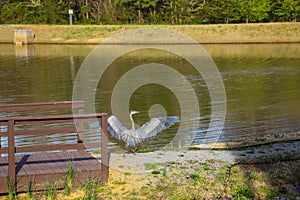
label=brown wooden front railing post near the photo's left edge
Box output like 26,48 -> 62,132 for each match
8,119 -> 17,191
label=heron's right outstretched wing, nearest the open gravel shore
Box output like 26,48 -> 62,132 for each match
137,116 -> 179,141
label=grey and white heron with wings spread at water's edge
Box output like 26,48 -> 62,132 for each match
90,110 -> 179,148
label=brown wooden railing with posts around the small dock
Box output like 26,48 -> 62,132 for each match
0,102 -> 109,191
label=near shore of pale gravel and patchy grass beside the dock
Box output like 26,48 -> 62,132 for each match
0,139 -> 300,200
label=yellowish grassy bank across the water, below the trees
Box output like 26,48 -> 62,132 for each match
0,23 -> 300,44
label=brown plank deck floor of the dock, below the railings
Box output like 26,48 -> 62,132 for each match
0,151 -> 102,194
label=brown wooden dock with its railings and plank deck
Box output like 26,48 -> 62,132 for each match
0,102 -> 109,194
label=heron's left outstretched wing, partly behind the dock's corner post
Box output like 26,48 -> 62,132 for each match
88,115 -> 127,140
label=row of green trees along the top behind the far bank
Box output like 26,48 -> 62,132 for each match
0,0 -> 300,24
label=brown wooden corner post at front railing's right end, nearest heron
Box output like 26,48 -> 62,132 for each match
101,115 -> 109,183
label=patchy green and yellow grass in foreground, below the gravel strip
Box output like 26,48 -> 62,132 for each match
0,160 -> 300,200
